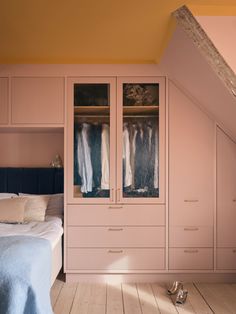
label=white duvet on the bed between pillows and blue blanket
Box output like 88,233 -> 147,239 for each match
0,216 -> 63,248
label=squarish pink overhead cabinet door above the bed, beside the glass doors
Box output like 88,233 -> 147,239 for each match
11,77 -> 64,125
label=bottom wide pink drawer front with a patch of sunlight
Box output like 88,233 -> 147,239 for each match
67,248 -> 165,271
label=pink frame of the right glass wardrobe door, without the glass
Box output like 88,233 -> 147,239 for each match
117,76 -> 166,204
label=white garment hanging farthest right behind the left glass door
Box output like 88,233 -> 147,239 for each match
101,124 -> 110,190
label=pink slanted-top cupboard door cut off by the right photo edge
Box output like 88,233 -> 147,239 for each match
217,128 -> 236,248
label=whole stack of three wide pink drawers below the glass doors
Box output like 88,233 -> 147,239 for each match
66,205 -> 165,273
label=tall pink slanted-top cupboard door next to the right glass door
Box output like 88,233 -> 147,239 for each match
169,83 -> 214,226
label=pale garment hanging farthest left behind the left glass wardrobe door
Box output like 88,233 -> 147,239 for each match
77,123 -> 93,193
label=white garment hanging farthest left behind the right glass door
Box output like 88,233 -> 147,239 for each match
122,123 -> 132,187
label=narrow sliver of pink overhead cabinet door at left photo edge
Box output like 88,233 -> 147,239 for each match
0,77 -> 9,124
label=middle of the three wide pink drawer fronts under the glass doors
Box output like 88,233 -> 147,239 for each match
67,226 -> 165,247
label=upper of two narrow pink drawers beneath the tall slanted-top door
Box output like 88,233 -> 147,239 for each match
170,226 -> 213,247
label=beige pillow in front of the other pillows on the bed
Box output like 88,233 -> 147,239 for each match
0,197 -> 27,223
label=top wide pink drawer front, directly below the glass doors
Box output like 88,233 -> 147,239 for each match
67,205 -> 165,226
